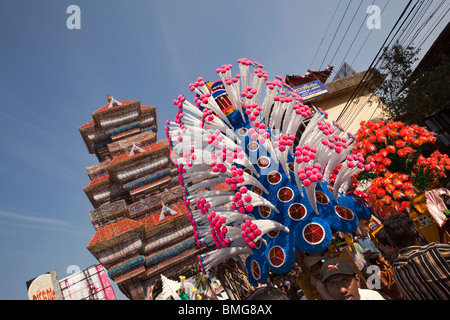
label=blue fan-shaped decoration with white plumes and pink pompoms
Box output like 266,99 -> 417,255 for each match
166,59 -> 374,285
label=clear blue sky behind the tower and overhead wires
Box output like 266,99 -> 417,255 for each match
0,0 -> 442,299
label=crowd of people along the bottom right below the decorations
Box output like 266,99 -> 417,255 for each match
248,214 -> 450,300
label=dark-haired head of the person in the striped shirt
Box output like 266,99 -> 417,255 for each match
383,214 -> 417,250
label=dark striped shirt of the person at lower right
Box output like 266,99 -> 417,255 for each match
393,242 -> 450,300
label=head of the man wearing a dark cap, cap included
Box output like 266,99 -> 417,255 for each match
320,258 -> 361,300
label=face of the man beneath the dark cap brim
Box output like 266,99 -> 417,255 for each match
325,274 -> 360,300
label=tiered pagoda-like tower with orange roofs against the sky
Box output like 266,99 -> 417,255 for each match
79,96 -> 203,300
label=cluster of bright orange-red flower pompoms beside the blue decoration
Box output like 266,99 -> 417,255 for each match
353,121 -> 450,217
